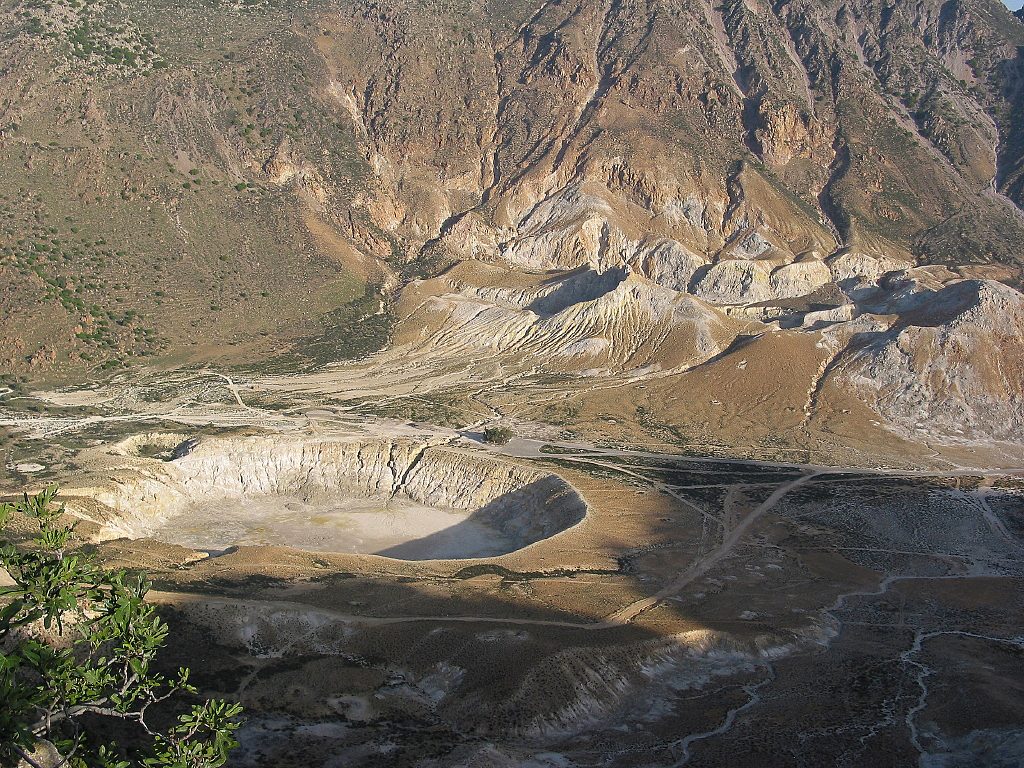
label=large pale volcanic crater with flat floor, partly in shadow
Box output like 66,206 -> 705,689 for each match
74,437 -> 587,560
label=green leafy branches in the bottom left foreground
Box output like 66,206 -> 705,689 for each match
0,486 -> 242,768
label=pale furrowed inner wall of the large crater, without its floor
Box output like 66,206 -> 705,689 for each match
69,436 -> 587,559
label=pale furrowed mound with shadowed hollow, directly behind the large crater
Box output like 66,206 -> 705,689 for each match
397,267 -> 741,374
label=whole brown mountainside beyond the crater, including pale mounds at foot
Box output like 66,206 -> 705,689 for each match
0,0 -> 1024,450
